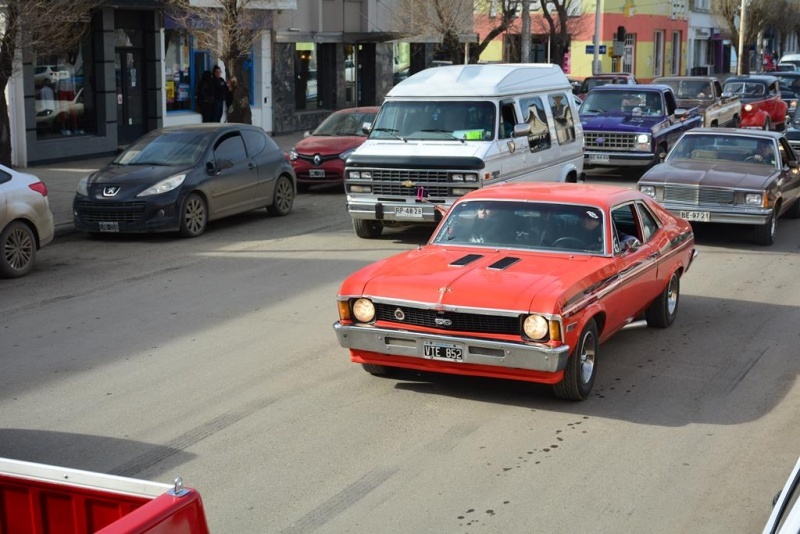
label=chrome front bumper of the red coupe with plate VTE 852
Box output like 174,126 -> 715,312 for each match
333,321 -> 569,373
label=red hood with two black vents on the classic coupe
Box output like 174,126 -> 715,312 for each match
340,246 -> 614,313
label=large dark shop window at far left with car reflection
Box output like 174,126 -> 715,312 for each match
33,44 -> 97,139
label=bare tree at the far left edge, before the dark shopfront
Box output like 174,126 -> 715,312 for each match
0,0 -> 100,166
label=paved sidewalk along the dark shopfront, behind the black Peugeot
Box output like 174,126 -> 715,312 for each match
25,132 -> 303,236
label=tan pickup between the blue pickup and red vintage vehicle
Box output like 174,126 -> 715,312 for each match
653,76 -> 742,128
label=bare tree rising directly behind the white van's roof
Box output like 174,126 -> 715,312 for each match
391,0 -> 519,64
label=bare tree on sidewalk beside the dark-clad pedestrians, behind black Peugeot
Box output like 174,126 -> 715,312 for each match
165,0 -> 272,124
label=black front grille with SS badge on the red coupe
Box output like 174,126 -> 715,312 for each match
375,304 -> 520,335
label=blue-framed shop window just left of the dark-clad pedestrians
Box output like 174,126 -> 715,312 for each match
164,30 -> 196,112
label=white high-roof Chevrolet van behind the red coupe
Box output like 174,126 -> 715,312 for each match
345,64 -> 583,238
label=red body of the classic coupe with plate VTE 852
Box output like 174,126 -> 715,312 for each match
334,184 -> 696,400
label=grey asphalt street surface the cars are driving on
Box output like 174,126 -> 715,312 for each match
0,177 -> 800,534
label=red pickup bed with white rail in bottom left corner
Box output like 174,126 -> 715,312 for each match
0,458 -> 209,534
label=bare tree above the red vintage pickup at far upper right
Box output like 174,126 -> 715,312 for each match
711,0 -> 781,74
